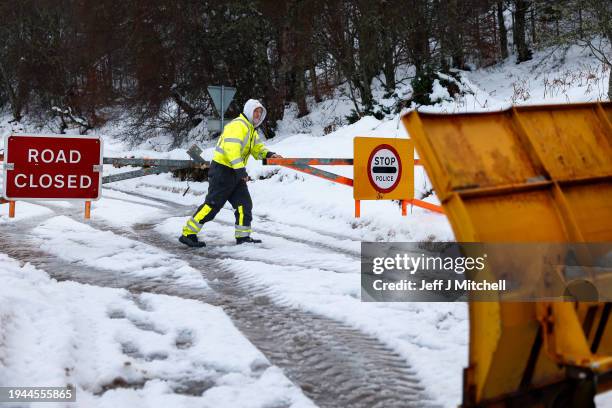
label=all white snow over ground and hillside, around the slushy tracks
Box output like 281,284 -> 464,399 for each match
0,43 -> 612,407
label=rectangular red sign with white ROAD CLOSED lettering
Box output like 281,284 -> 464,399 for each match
4,135 -> 102,200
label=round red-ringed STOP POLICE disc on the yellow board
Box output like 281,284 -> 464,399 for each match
368,144 -> 402,193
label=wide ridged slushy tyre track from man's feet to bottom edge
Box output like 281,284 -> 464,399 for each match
130,224 -> 437,408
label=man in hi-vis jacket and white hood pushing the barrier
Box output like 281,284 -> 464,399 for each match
179,99 -> 282,248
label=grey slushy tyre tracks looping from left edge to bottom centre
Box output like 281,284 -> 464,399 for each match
0,198 -> 436,408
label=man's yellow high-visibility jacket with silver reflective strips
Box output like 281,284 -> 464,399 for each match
213,114 -> 271,177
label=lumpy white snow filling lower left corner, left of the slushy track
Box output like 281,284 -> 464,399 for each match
0,255 -> 313,408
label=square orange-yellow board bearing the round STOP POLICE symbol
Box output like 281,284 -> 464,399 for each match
353,137 -> 414,200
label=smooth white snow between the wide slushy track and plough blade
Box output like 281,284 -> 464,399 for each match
224,260 -> 468,406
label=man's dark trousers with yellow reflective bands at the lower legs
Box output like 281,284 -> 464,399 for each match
183,161 -> 253,238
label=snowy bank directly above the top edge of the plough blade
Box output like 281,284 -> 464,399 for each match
419,46 -> 610,113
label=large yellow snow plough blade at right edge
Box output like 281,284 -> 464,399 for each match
402,103 -> 612,407
